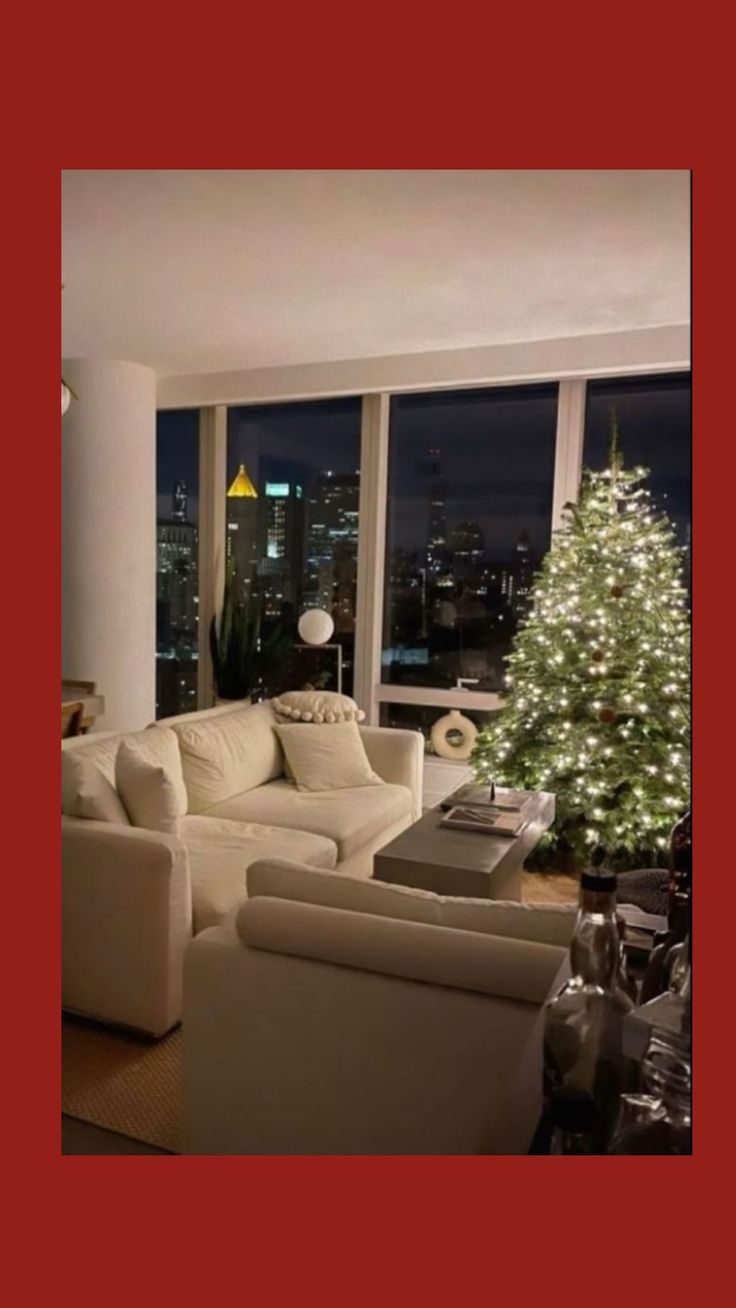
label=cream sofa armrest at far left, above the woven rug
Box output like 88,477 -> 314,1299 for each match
61,818 -> 191,1036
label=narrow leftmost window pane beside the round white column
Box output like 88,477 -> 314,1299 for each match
156,409 -> 199,718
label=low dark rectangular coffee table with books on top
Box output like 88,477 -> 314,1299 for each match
373,790 -> 554,900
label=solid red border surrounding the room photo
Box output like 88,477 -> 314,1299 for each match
3,15 -> 733,1304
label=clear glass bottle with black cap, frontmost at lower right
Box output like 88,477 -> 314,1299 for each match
544,867 -> 634,1154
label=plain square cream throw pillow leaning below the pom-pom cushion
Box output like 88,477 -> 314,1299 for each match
276,722 -> 383,790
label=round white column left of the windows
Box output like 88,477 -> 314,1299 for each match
61,358 -> 156,730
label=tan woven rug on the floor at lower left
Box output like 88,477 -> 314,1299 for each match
61,1018 -> 182,1154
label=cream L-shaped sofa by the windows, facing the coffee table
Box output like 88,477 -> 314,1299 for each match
61,702 -> 424,1036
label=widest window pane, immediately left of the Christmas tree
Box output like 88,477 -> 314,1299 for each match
382,385 -> 558,734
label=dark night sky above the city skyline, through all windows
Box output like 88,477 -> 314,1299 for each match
157,377 -> 690,559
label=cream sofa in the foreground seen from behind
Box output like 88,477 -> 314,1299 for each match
183,859 -> 575,1155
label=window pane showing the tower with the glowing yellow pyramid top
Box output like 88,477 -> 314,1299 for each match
226,398 -> 361,695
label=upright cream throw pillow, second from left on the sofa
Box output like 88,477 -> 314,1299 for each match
115,732 -> 187,836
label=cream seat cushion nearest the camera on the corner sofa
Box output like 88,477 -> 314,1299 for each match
179,814 -> 337,931
